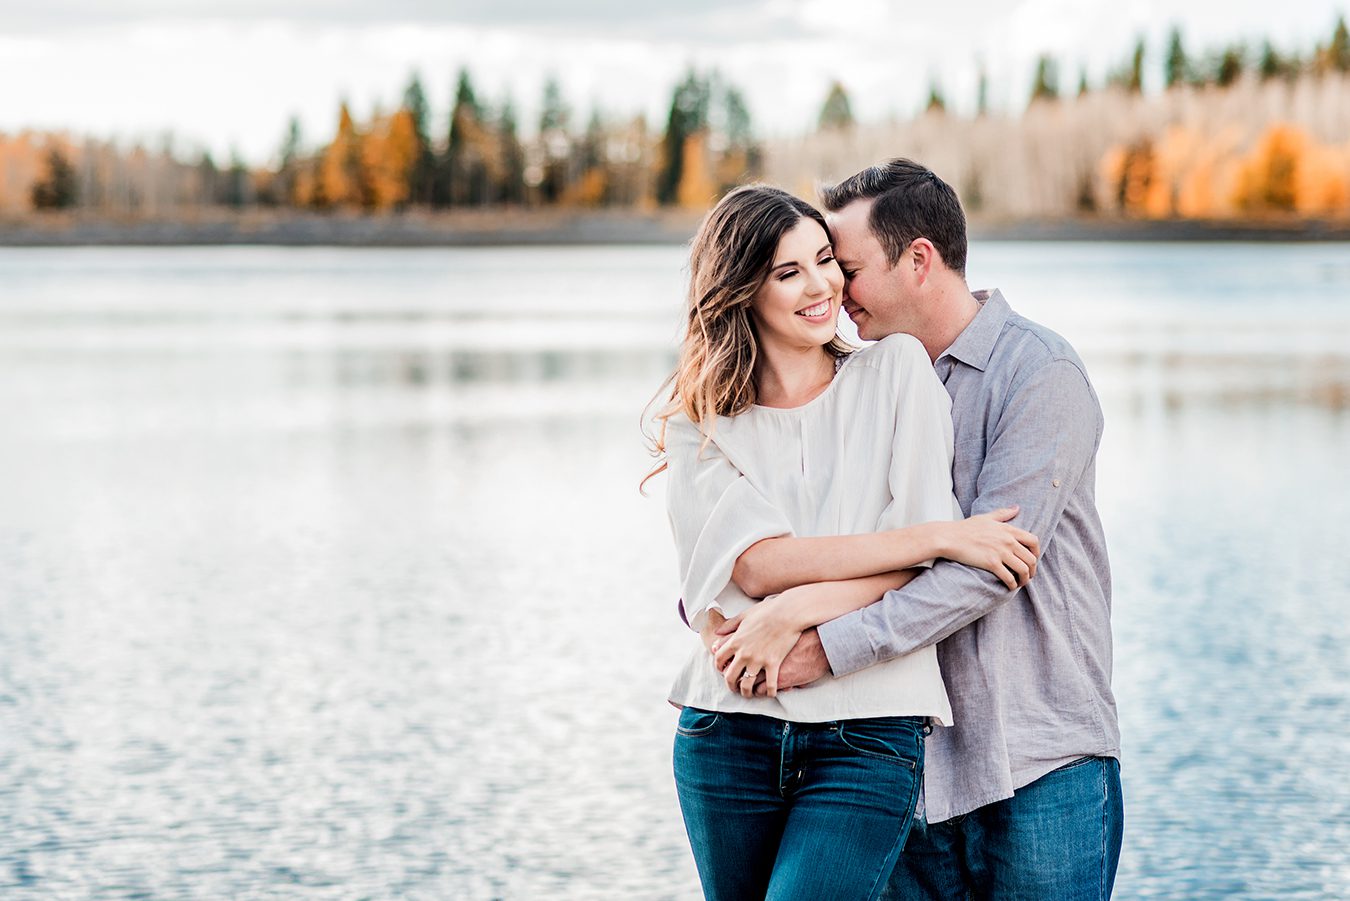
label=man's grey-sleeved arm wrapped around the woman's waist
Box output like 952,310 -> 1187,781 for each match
815,359 -> 1102,675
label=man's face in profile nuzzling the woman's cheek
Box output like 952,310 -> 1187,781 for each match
829,200 -> 918,340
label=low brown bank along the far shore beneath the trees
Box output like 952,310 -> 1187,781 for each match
0,209 -> 1350,247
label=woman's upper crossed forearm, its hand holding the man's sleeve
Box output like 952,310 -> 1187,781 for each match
732,507 -> 1040,599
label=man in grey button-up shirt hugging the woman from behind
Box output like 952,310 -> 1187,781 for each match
756,159 -> 1123,901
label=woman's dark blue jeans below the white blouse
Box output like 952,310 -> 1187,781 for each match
675,708 -> 925,901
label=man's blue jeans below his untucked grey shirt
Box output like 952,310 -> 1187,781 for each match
884,756 -> 1125,901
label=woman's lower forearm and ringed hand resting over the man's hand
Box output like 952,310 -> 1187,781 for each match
703,570 -> 917,697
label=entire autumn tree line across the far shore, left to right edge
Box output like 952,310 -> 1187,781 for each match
10,16 -> 1350,217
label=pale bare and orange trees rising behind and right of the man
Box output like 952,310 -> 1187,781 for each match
765,18 -> 1350,219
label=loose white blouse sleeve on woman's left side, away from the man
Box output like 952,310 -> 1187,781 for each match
666,415 -> 792,631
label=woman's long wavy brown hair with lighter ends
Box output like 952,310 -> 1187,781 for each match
643,185 -> 852,494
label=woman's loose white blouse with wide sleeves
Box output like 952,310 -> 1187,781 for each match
666,335 -> 961,725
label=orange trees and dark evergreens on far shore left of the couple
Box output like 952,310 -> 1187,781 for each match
10,69 -> 763,215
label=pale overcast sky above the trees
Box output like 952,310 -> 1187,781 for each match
0,0 -> 1350,162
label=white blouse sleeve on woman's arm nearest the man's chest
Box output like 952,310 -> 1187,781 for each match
876,335 -> 960,553
